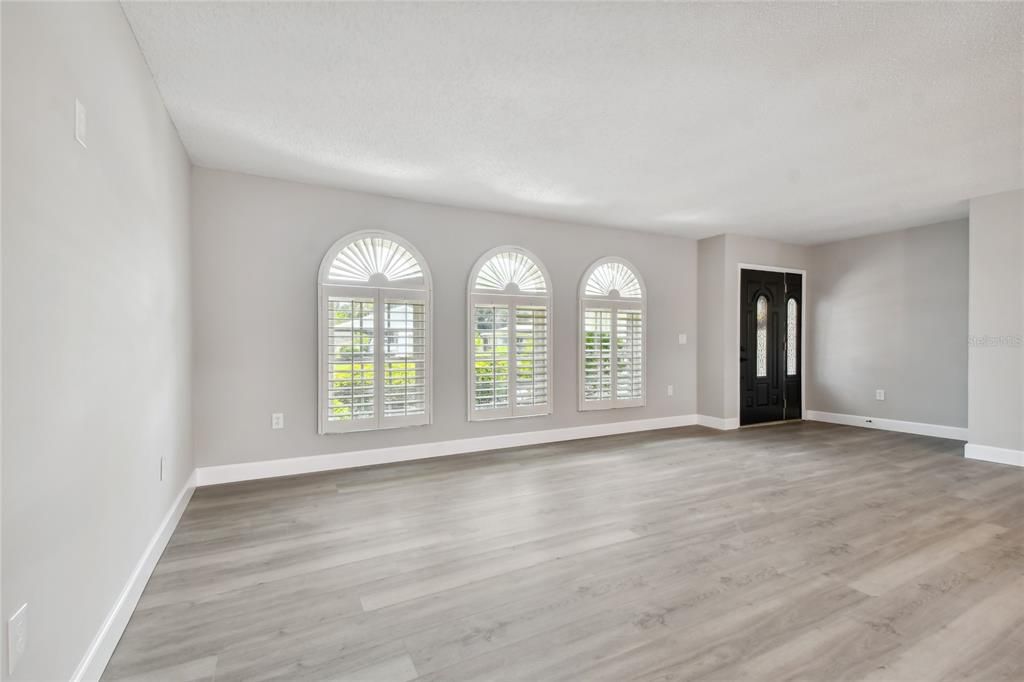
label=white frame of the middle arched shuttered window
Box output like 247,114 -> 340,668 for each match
466,246 -> 555,422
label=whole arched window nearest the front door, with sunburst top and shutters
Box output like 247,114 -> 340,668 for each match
580,258 -> 647,410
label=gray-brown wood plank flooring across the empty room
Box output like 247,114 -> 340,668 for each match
104,422 -> 1024,682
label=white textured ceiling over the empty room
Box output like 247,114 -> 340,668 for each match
124,2 -> 1024,243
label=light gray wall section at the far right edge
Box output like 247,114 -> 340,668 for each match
968,189 -> 1024,451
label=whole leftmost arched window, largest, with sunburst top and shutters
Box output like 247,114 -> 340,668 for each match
317,231 -> 431,433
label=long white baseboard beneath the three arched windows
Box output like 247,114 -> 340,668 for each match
196,415 -> 697,485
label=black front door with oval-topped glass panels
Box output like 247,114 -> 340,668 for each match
739,269 -> 804,425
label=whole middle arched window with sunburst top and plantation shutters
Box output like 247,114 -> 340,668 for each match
469,247 -> 551,421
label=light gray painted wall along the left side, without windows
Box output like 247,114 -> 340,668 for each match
2,3 -> 193,680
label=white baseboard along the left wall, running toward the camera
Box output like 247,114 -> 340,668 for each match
71,471 -> 196,682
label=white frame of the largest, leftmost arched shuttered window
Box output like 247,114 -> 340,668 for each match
316,230 -> 434,435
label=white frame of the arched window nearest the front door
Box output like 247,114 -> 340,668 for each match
577,256 -> 649,412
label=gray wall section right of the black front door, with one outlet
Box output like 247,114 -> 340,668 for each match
807,220 -> 968,427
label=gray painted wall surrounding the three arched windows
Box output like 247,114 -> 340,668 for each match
193,168 -> 697,466
